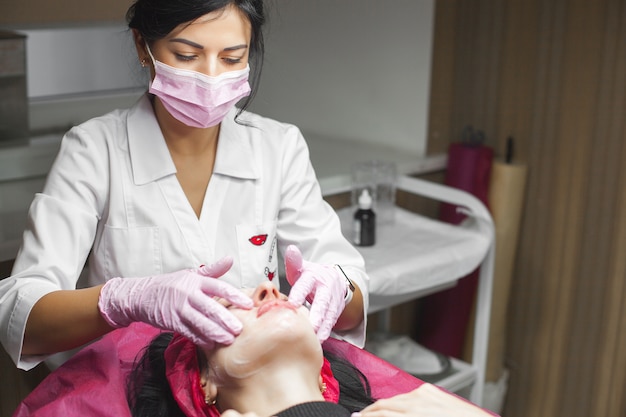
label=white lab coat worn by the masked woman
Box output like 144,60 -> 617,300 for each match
0,95 -> 368,369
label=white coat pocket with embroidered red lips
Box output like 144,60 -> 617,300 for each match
237,221 -> 279,288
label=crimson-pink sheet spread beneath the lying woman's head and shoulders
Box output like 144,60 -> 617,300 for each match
13,323 -> 423,417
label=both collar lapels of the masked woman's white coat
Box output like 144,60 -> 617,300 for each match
128,94 -> 259,185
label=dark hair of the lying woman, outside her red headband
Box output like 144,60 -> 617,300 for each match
127,333 -> 374,417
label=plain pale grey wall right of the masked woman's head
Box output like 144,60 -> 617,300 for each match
253,0 -> 434,156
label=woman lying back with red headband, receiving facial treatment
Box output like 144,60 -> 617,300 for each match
128,282 -> 490,417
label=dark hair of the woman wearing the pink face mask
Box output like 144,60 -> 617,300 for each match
126,0 -> 265,117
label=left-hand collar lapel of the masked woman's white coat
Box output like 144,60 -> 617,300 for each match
127,93 -> 176,185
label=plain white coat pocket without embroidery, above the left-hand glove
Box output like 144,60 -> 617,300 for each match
104,226 -> 162,278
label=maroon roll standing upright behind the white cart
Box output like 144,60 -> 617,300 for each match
417,143 -> 493,358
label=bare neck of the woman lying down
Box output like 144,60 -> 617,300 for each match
217,364 -> 324,417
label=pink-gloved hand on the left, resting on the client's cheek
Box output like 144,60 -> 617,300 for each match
98,257 -> 253,349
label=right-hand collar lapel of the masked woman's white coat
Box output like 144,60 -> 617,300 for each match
213,107 -> 259,179
